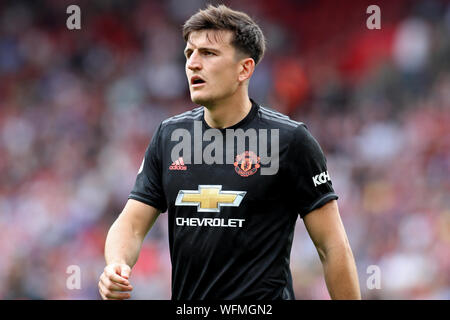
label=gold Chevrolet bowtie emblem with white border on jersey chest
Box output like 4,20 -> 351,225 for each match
175,185 -> 247,212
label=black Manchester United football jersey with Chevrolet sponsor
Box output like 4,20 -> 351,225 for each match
129,100 -> 338,300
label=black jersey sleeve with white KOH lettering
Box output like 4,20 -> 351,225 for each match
286,124 -> 338,218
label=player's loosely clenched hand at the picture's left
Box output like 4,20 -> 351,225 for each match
98,263 -> 133,300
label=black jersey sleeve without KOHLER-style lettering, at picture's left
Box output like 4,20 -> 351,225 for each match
128,125 -> 167,212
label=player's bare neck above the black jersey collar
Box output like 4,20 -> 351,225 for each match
205,94 -> 252,129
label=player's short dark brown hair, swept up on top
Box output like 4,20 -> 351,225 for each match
183,5 -> 266,64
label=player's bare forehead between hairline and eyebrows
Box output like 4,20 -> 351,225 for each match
186,29 -> 233,49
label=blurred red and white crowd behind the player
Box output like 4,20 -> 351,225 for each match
0,0 -> 450,299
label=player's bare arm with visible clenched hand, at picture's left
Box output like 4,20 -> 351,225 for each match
98,199 -> 161,300
